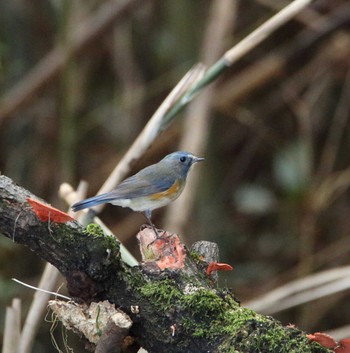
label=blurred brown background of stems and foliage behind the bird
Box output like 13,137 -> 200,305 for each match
0,0 -> 350,353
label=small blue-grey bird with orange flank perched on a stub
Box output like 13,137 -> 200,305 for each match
72,151 -> 204,229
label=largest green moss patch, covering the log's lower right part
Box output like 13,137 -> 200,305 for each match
140,278 -> 331,353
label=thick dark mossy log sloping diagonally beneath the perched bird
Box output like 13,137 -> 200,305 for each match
0,176 -> 329,353
